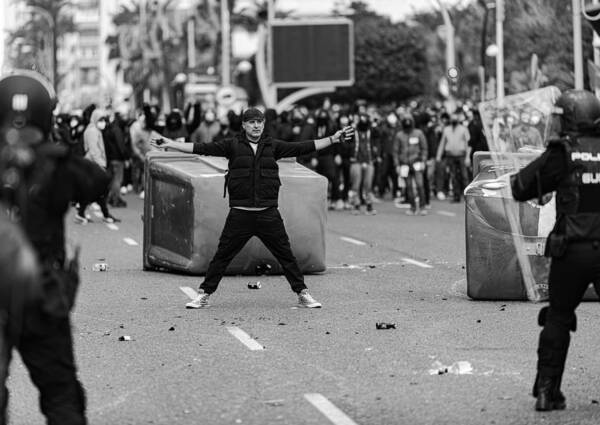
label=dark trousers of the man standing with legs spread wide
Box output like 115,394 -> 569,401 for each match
200,207 -> 306,294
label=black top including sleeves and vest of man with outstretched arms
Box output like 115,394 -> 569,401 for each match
194,132 -> 315,208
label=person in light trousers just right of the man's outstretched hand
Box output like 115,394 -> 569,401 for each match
348,114 -> 376,215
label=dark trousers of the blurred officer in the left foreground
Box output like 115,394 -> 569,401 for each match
0,313 -> 87,425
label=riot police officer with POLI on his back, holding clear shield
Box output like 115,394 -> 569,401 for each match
510,90 -> 600,411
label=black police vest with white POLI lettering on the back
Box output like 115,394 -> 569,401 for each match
555,136 -> 600,241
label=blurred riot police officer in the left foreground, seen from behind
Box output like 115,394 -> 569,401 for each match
0,71 -> 108,425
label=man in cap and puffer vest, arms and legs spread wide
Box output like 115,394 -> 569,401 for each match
154,108 -> 352,308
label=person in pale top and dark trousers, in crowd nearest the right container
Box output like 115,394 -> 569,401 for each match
436,114 -> 471,202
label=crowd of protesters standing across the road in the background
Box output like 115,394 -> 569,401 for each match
54,97 -> 488,220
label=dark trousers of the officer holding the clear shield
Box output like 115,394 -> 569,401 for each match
538,242 -> 600,376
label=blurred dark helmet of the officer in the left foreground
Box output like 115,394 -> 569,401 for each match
0,70 -> 56,144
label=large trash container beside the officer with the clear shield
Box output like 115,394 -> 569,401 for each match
465,152 -> 597,300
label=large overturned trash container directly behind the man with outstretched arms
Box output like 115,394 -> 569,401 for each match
143,152 -> 327,275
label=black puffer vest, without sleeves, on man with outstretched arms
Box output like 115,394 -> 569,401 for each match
226,134 -> 281,208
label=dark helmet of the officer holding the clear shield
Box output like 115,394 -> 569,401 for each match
555,90 -> 600,133
